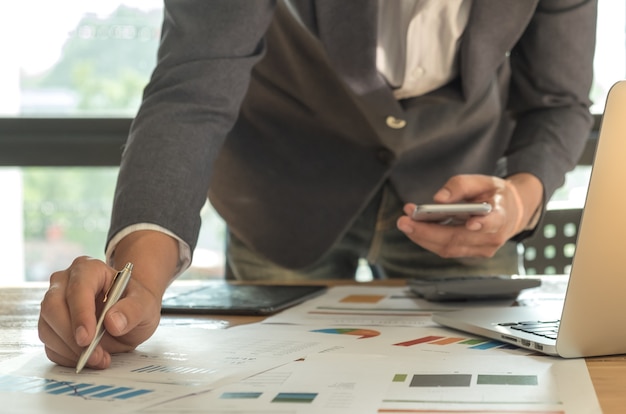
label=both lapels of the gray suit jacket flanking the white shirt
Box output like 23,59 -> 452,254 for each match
315,0 -> 538,109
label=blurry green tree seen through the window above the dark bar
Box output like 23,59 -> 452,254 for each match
31,5 -> 162,116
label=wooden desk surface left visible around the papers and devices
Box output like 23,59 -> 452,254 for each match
0,281 -> 626,414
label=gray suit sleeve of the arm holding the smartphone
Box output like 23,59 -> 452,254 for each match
507,0 -> 597,201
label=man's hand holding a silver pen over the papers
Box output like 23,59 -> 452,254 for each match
38,231 -> 178,369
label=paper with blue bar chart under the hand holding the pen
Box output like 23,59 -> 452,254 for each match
0,324 -> 354,414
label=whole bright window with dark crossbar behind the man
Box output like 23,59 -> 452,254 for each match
0,0 -> 626,283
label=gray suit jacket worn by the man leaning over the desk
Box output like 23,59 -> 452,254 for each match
109,0 -> 596,267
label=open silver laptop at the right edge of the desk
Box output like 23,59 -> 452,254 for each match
433,81 -> 626,358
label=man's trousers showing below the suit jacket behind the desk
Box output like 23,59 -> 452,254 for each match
226,183 -> 522,281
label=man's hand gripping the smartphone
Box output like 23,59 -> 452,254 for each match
397,173 -> 543,258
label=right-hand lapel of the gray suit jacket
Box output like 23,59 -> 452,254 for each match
460,0 -> 538,99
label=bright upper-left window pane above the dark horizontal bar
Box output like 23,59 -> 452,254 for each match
0,0 -> 162,117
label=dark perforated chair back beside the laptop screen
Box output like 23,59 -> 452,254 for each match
523,208 -> 582,275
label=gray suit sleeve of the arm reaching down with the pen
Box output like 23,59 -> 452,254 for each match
108,0 -> 274,251
